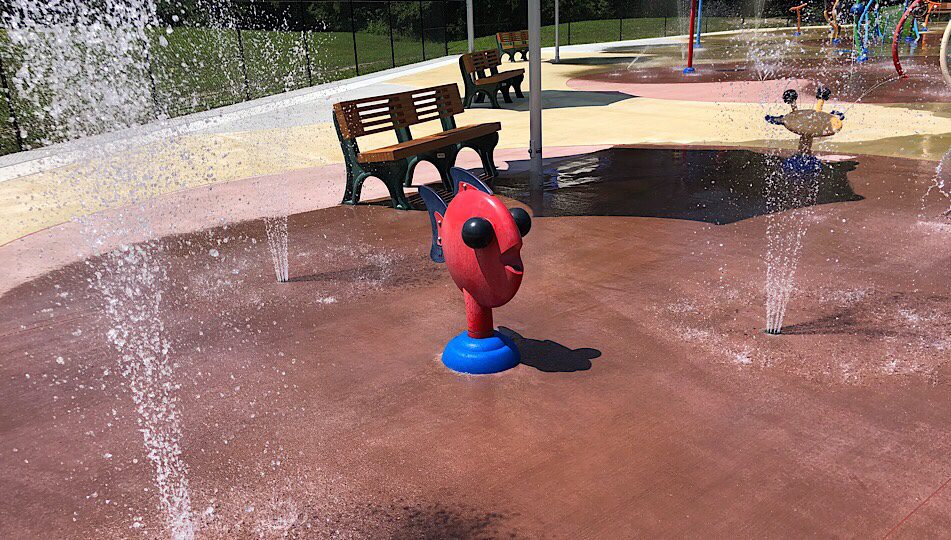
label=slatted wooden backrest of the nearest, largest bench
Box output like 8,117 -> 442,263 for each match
334,84 -> 463,139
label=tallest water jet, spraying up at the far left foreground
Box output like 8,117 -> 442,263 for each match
4,0 -> 195,540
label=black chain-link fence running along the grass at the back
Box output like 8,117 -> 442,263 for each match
0,0 -> 821,155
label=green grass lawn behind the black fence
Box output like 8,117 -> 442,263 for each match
0,17 -> 768,155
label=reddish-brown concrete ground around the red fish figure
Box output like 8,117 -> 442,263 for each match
0,149 -> 951,538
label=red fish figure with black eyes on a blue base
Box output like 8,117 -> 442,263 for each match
419,167 -> 532,374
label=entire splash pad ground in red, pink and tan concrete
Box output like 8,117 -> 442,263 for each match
0,11 -> 951,539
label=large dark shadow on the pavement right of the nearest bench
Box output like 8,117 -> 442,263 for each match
493,147 -> 862,225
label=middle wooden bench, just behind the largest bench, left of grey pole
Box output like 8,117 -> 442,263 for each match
459,49 -> 525,109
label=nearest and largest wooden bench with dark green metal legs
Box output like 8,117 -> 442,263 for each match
334,84 -> 502,210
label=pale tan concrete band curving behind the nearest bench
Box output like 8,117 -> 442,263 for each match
0,26 -> 951,245
